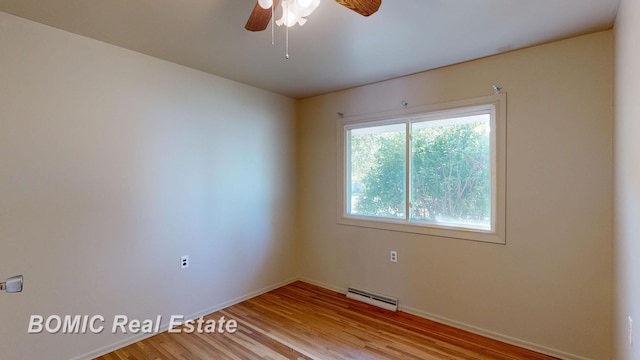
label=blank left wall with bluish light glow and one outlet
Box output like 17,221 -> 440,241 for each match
0,13 -> 296,360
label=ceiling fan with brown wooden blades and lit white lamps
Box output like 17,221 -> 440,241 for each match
244,0 -> 382,31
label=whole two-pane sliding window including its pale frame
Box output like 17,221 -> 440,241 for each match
338,94 -> 506,243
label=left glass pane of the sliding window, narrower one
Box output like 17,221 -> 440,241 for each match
347,123 -> 406,219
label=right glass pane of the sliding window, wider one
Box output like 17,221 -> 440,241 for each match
411,114 -> 491,230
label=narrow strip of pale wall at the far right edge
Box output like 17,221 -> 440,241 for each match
612,0 -> 640,360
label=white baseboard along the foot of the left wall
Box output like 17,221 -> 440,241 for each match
71,278 -> 298,360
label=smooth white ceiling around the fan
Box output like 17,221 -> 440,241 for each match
0,0 -> 620,98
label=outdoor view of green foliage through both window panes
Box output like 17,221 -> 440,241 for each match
349,114 -> 491,229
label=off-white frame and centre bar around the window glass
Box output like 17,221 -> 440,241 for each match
337,93 -> 506,244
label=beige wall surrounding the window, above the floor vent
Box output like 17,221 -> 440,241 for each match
298,31 -> 612,359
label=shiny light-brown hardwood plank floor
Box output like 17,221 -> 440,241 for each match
98,282 -> 555,360
